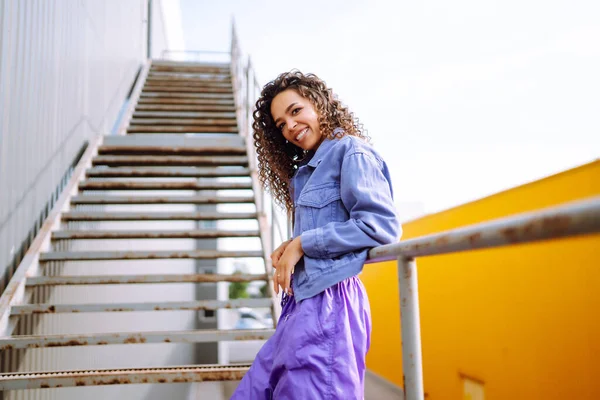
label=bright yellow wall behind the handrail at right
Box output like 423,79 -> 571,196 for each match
361,161 -> 600,400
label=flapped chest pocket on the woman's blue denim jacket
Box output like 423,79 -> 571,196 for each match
297,183 -> 344,231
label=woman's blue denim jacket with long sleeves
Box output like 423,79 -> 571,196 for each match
291,133 -> 401,302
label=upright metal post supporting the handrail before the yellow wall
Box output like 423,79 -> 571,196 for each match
398,256 -> 424,400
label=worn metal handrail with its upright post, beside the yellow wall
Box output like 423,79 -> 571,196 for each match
367,196 -> 600,400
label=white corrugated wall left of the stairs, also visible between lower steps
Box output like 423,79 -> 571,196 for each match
0,0 -> 209,400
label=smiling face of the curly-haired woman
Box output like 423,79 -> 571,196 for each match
271,89 -> 324,150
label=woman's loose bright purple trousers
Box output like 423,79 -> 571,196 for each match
231,276 -> 371,400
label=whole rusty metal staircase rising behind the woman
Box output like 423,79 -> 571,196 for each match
0,57 -> 277,391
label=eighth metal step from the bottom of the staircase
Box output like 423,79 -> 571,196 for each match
71,195 -> 254,204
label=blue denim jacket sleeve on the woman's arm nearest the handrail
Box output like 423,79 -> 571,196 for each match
301,152 -> 402,258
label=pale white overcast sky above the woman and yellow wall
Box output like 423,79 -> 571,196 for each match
165,0 -> 600,219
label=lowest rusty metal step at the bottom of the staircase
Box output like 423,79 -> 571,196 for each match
0,365 -> 250,390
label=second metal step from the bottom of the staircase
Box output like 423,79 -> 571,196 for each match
0,329 -> 275,350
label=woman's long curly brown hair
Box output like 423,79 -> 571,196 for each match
252,70 -> 370,213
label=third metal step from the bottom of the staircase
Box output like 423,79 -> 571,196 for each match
11,298 -> 273,315
